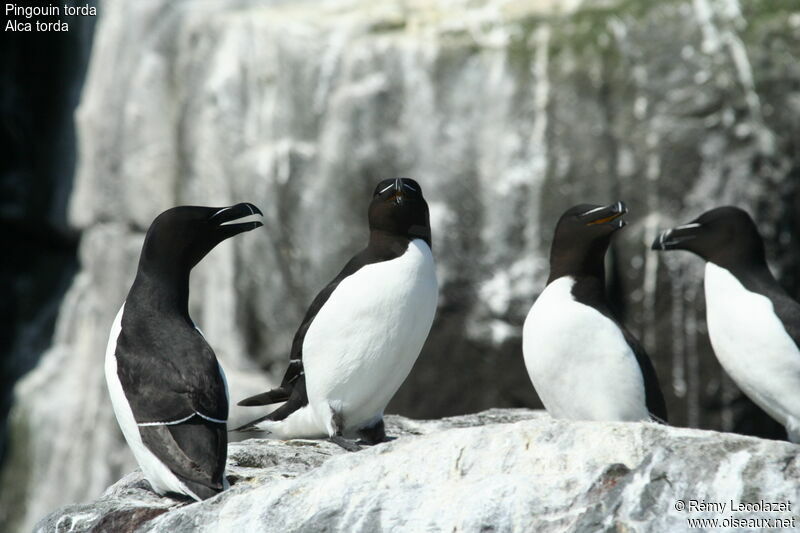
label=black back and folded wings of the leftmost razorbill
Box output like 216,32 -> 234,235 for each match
115,312 -> 228,498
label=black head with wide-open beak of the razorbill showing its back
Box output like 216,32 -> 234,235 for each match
139,203 -> 262,274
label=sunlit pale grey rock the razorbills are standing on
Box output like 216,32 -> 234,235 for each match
35,409 -> 800,533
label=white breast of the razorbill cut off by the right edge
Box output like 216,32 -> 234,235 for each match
705,262 -> 800,440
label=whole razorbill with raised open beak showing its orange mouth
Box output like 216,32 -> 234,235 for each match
522,202 -> 667,422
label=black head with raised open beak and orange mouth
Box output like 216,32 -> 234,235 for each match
549,202 -> 628,281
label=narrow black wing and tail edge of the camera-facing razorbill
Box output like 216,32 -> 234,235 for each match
239,241 -> 408,410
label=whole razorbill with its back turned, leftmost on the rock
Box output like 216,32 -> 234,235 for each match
105,203 -> 261,500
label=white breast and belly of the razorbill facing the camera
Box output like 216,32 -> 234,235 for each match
303,239 -> 438,428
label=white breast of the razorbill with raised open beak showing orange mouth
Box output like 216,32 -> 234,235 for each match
522,276 -> 649,420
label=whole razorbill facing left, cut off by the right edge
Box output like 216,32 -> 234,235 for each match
653,206 -> 800,442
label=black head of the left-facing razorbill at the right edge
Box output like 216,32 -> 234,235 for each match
653,206 -> 766,267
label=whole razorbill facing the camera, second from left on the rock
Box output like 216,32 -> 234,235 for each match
238,178 -> 438,450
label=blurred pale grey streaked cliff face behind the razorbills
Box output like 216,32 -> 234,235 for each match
0,0 -> 800,531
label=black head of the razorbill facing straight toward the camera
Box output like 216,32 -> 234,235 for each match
369,178 -> 431,246
